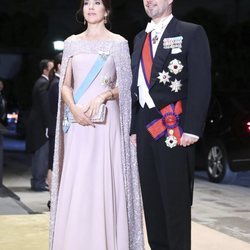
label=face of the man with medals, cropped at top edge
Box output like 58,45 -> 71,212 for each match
143,0 -> 173,20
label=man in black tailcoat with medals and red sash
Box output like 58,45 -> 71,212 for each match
131,0 -> 210,250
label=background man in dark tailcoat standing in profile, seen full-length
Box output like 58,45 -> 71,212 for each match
26,59 -> 53,191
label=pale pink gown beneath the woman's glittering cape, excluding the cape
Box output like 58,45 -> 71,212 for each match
53,53 -> 129,250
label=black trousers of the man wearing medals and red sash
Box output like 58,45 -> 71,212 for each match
137,107 -> 193,250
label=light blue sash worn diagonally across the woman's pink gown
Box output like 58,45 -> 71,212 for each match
62,54 -> 108,133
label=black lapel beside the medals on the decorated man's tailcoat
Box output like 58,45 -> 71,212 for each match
150,17 -> 178,88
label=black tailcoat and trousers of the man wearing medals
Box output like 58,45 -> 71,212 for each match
131,18 -> 211,250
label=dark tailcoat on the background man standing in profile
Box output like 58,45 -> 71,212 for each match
26,76 -> 49,153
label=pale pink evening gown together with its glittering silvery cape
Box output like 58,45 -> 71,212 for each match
51,39 -> 143,250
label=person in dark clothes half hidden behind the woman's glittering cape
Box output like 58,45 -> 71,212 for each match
47,53 -> 62,208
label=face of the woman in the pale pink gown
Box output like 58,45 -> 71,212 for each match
83,0 -> 107,24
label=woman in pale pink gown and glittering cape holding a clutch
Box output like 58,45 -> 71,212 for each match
51,0 -> 144,250
